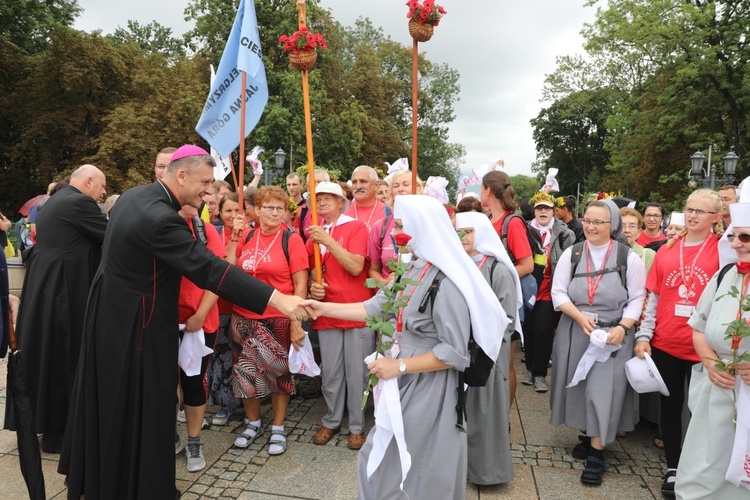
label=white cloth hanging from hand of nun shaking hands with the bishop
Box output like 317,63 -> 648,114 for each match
365,353 -> 411,491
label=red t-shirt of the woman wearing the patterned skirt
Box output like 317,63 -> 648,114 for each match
233,226 -> 307,319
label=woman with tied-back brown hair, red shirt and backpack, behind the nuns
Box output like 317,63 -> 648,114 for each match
481,170 -> 534,404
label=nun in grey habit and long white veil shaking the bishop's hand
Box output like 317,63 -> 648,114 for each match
303,195 -> 510,500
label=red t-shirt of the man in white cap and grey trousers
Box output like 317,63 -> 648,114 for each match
307,219 -> 375,330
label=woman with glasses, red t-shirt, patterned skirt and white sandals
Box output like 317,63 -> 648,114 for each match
231,186 -> 308,455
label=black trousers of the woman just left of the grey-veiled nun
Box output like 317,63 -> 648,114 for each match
523,300 -> 560,377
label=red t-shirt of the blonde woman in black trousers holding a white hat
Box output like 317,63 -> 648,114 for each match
646,233 -> 719,362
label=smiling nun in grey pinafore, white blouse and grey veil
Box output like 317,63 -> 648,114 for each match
550,200 -> 646,485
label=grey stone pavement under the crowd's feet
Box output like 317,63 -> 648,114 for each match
0,350 -> 665,500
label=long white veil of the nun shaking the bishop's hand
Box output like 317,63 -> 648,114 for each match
394,195 -> 510,359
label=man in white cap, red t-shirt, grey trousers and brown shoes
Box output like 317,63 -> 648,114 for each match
307,182 -> 375,450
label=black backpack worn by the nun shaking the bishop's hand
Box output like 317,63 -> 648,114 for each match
419,260 -> 497,429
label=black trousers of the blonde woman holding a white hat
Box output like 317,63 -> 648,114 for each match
651,347 -> 695,469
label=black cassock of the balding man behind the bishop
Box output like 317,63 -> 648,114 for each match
16,186 -> 107,446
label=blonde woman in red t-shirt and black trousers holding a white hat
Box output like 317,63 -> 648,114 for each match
635,189 -> 724,496
